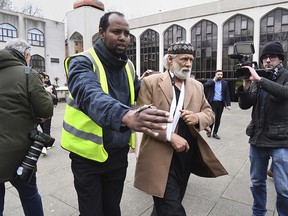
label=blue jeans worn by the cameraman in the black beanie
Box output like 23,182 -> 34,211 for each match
250,145 -> 288,216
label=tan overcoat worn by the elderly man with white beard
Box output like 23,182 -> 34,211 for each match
134,71 -> 227,197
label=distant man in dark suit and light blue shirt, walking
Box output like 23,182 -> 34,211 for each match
203,70 -> 231,139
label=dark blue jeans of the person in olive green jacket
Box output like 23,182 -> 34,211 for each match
0,174 -> 44,216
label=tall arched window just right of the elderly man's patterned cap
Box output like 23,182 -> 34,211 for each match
191,20 -> 218,79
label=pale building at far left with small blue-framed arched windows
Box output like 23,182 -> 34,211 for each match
0,9 -> 66,85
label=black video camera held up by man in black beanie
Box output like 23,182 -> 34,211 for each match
228,42 -> 273,79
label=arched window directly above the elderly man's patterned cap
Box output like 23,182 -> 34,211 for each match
164,25 -> 186,54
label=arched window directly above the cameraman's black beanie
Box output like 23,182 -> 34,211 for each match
259,8 -> 288,67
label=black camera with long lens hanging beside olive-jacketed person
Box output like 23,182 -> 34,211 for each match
17,129 -> 55,182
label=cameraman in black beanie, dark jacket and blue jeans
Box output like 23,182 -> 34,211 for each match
237,42 -> 288,216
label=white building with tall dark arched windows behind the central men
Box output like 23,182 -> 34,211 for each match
67,0 -> 288,97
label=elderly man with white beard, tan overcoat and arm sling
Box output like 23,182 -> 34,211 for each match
134,42 -> 226,216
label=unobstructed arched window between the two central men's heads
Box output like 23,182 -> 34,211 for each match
140,29 -> 159,75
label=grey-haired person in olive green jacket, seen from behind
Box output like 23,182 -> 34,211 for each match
0,38 -> 53,216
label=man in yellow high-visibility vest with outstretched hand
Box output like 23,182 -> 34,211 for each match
61,12 -> 171,216
